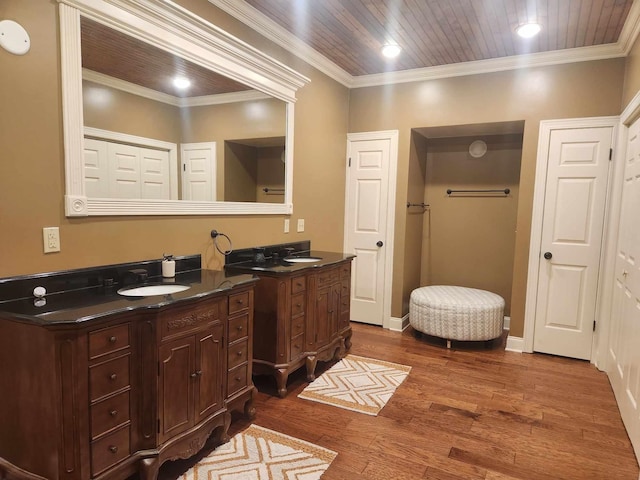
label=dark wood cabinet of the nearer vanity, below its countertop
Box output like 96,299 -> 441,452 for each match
0,283 -> 255,480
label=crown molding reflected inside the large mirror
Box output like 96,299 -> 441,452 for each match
82,68 -> 273,107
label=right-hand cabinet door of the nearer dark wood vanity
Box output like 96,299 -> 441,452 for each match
195,324 -> 226,423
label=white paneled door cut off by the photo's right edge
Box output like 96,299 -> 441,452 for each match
607,114 -> 640,455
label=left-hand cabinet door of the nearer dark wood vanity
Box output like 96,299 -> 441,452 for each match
158,336 -> 195,443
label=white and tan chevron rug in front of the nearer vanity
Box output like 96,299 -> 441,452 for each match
178,425 -> 337,480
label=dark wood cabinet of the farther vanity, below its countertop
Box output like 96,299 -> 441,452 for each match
253,259 -> 351,397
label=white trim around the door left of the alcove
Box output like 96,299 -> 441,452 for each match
343,130 -> 402,329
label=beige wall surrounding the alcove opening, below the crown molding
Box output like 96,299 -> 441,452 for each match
349,59 -> 624,336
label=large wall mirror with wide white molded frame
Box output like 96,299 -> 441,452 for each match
59,0 -> 308,216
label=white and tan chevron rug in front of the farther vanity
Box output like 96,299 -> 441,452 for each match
298,355 -> 411,415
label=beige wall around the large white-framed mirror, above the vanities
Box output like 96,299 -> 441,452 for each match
0,0 -> 349,277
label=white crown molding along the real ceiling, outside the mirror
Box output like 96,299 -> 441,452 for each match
209,0 -> 640,88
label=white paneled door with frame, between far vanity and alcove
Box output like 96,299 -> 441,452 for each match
345,132 -> 397,325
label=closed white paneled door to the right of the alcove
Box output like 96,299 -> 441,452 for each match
533,126 -> 614,360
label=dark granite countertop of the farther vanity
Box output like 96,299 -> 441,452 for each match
224,250 -> 355,275
